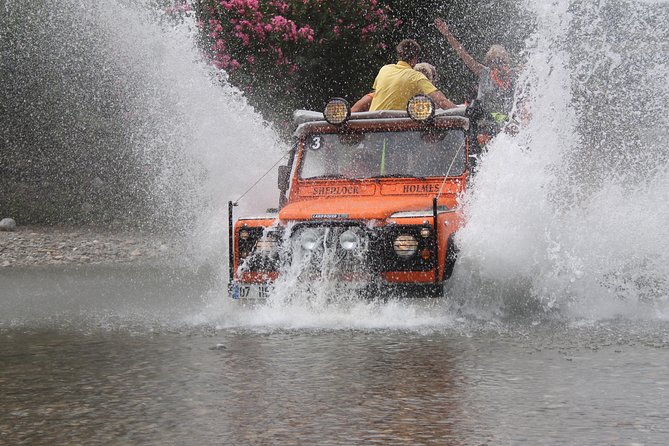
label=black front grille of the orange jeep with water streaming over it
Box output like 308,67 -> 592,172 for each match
235,221 -> 437,283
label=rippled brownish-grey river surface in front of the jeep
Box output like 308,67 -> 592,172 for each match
0,269 -> 669,445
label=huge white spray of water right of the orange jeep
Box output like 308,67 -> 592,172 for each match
451,1 -> 669,318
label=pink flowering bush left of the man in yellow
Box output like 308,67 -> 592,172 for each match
197,0 -> 398,127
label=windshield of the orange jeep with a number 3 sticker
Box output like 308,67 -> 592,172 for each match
300,129 -> 466,180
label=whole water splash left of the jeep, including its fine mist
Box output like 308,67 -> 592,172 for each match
0,0 -> 284,261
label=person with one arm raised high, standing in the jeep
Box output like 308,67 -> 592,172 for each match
434,18 -> 517,141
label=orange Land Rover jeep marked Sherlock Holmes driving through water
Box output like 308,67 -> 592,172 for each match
229,96 -> 469,298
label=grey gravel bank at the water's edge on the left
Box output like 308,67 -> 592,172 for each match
0,227 -> 183,269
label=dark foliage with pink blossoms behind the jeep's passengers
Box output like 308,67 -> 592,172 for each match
198,0 -> 530,123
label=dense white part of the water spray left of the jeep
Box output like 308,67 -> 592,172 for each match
82,2 -> 285,262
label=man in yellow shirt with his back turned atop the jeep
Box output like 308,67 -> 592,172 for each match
369,39 -> 455,110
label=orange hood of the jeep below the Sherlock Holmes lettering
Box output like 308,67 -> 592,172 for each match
279,196 -> 456,221
